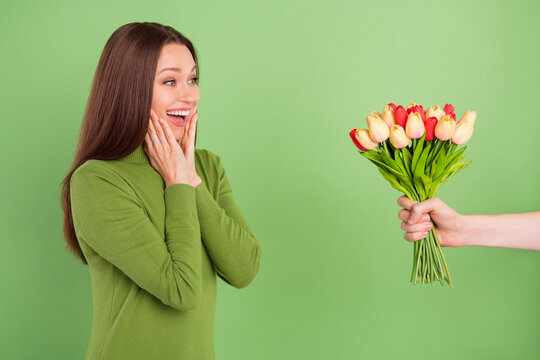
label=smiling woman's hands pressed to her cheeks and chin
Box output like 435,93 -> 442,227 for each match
144,110 -> 201,187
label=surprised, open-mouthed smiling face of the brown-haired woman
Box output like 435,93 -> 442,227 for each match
152,44 -> 199,142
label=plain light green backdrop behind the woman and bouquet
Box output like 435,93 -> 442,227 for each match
0,0 -> 540,360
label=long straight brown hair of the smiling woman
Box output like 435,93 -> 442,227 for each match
61,22 -> 199,264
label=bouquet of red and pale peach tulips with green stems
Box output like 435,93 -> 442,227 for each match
350,103 -> 476,286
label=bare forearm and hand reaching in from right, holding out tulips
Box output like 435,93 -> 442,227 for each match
398,196 -> 540,250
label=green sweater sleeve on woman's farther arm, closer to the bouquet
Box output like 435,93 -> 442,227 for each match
195,154 -> 261,288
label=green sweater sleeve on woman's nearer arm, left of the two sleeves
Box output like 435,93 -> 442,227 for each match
70,165 -> 202,310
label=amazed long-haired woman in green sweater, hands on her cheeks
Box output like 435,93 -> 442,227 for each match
62,23 -> 261,360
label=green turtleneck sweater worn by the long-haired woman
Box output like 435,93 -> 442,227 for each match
71,144 -> 261,360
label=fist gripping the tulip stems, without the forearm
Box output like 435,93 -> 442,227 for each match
398,196 -> 464,246
